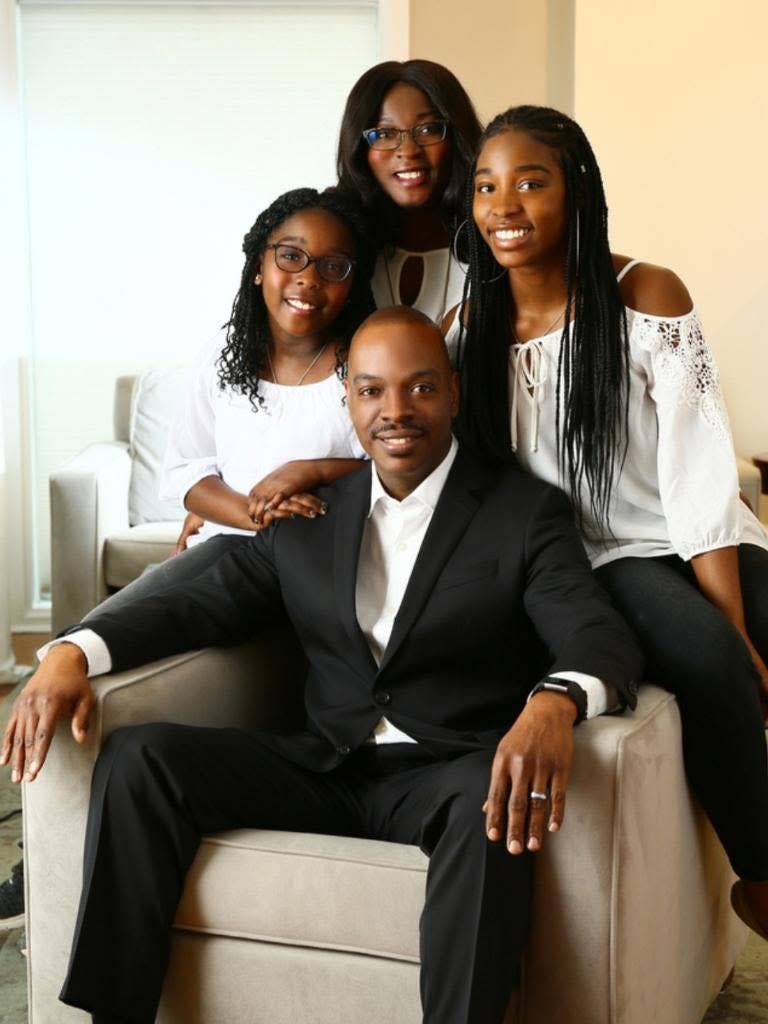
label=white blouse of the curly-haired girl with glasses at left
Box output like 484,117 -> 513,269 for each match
161,337 -> 366,543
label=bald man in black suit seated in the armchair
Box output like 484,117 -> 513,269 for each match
2,309 -> 641,1024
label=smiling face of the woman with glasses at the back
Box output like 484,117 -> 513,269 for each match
368,82 -> 451,209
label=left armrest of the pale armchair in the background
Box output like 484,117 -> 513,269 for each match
49,441 -> 131,634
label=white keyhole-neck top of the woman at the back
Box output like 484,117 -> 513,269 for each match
371,249 -> 467,324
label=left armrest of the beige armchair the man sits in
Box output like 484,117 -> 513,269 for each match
23,630 -> 305,1024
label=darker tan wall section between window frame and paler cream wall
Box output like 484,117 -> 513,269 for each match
410,0 -> 573,121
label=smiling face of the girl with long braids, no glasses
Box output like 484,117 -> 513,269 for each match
472,131 -> 567,269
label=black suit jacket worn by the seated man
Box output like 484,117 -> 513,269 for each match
83,451 -> 642,770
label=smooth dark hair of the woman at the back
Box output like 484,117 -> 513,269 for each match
336,59 -> 482,246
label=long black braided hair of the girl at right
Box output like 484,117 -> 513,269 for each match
460,105 -> 629,528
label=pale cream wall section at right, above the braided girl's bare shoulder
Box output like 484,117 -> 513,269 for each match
574,0 -> 768,455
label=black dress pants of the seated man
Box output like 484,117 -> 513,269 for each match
60,724 -> 532,1024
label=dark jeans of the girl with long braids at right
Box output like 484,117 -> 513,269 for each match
596,544 -> 768,882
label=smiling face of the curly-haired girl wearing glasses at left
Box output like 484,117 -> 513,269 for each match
255,209 -> 355,345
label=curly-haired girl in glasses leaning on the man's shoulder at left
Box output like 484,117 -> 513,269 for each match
83,188 -> 376,609
